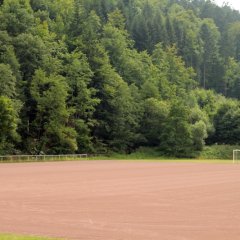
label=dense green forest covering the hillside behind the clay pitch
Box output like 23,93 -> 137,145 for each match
0,0 -> 240,157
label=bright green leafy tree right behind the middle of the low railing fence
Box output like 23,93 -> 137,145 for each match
30,70 -> 77,153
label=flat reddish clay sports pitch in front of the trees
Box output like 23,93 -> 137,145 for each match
0,161 -> 240,240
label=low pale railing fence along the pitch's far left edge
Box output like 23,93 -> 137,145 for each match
0,154 -> 90,162
